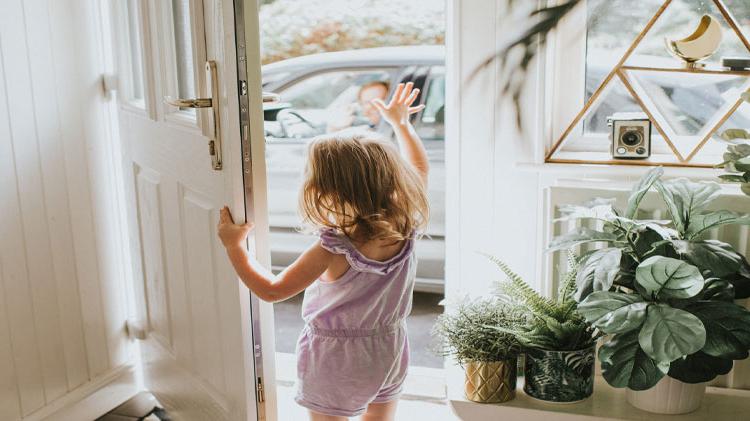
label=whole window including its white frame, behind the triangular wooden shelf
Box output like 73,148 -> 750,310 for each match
552,0 -> 750,161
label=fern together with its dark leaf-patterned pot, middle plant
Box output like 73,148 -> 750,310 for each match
490,257 -> 596,403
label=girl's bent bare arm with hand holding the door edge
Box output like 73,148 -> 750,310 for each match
218,207 -> 333,302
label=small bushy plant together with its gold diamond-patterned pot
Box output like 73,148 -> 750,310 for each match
433,298 -> 523,403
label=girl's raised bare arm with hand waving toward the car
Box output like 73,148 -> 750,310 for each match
373,82 -> 430,185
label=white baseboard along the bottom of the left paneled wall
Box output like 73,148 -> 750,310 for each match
23,365 -> 138,421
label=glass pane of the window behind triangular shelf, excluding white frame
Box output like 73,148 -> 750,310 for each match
585,0 -> 750,136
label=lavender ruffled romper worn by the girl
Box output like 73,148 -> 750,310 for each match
295,230 -> 416,417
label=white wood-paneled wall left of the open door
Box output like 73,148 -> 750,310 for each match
0,0 -> 130,420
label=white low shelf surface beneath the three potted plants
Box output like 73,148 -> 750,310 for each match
447,367 -> 750,421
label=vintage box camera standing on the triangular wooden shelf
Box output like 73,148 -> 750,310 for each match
607,113 -> 651,159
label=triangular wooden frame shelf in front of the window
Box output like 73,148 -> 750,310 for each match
545,0 -> 750,167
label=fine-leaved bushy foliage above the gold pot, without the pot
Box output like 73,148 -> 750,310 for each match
433,298 -> 525,363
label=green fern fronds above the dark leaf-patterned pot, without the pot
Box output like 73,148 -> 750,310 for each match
487,255 -> 596,351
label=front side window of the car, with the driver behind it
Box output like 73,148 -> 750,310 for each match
266,69 -> 400,138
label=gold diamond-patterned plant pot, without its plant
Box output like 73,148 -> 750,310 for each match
464,358 -> 517,403
